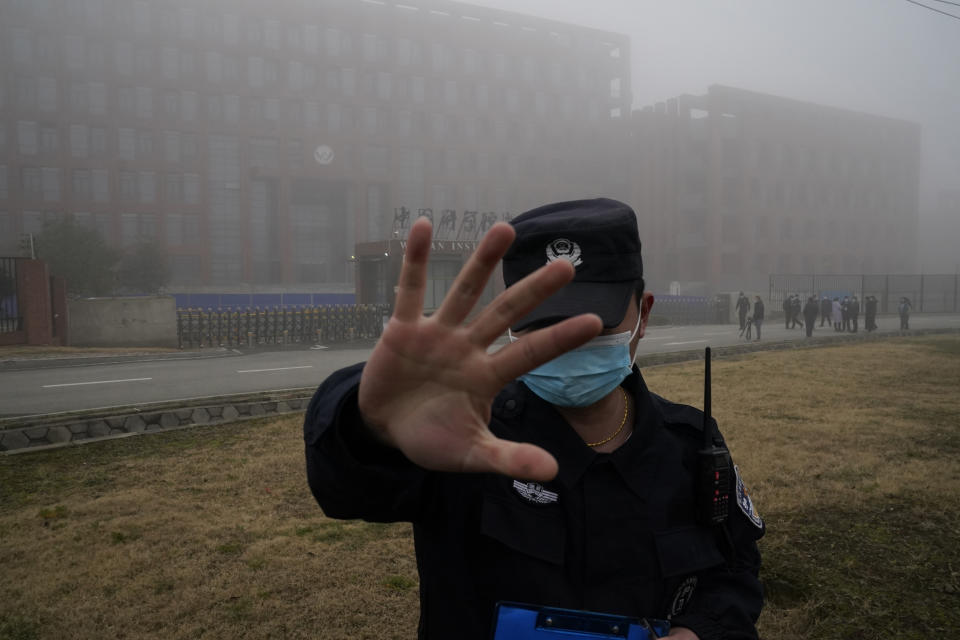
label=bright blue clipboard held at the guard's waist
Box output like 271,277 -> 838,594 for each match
491,602 -> 670,640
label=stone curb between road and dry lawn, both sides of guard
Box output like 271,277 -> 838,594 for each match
0,328 -> 960,455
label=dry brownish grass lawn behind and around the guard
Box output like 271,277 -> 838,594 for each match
0,335 -> 960,640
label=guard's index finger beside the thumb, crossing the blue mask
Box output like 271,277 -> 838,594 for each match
490,314 -> 603,387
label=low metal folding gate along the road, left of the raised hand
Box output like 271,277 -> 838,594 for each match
177,304 -> 390,349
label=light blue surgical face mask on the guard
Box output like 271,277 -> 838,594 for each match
510,317 -> 640,407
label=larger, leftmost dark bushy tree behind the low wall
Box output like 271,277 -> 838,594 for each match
36,218 -> 120,296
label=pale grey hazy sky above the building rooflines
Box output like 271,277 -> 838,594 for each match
470,0 -> 960,205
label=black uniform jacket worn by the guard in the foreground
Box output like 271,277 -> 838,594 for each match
304,365 -> 764,640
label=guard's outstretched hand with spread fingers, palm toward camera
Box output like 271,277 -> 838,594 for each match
358,218 -> 603,481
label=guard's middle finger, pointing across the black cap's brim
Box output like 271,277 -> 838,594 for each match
470,260 -> 575,345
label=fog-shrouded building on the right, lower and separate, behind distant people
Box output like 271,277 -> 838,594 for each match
631,86 -> 920,293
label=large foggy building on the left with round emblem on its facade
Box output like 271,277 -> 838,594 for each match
0,0 -> 631,286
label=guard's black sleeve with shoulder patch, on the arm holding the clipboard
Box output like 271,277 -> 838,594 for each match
671,460 -> 766,640
